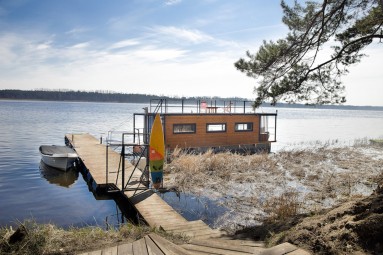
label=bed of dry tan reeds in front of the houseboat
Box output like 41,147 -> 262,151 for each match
165,139 -> 383,228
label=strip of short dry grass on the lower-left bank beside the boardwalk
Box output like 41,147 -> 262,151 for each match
0,220 -> 187,254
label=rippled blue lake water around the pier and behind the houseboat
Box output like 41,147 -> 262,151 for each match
0,100 -> 383,227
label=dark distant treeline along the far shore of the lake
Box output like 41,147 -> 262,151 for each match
0,89 -> 383,111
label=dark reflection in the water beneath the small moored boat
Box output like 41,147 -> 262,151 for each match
40,160 -> 79,188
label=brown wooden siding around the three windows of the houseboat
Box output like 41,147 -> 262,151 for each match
164,114 -> 260,149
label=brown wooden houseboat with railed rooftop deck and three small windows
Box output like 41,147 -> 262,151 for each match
134,100 -> 277,153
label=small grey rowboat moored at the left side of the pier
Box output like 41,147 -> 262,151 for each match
39,145 -> 78,171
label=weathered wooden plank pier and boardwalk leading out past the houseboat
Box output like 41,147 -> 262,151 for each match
65,134 -> 309,255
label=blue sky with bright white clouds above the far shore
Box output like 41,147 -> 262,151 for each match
0,0 -> 383,106
